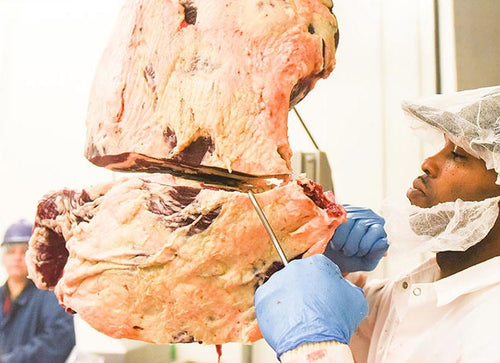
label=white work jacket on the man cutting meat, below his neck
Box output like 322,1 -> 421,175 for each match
350,257 -> 500,363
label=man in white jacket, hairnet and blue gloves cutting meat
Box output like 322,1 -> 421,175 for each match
255,87 -> 500,363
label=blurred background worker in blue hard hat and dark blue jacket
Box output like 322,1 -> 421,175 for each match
0,220 -> 75,363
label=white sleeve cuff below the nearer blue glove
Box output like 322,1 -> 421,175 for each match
280,341 -> 354,363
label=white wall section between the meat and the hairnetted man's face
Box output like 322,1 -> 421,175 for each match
289,0 -> 438,282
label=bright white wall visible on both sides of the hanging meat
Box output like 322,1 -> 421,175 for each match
0,0 -> 434,363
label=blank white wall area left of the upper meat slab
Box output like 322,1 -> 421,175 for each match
0,0 -> 122,247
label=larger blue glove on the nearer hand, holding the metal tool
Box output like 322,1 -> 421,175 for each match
254,255 -> 368,358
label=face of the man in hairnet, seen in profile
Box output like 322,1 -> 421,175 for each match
406,139 -> 500,208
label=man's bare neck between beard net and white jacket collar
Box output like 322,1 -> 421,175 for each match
436,218 -> 500,278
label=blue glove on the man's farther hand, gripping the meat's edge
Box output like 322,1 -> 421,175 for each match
324,205 -> 389,272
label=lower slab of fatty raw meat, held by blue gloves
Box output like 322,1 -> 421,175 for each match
26,175 -> 346,344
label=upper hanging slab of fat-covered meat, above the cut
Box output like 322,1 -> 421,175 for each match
85,0 -> 338,179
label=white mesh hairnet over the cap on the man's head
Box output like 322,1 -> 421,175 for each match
402,86 -> 500,184
